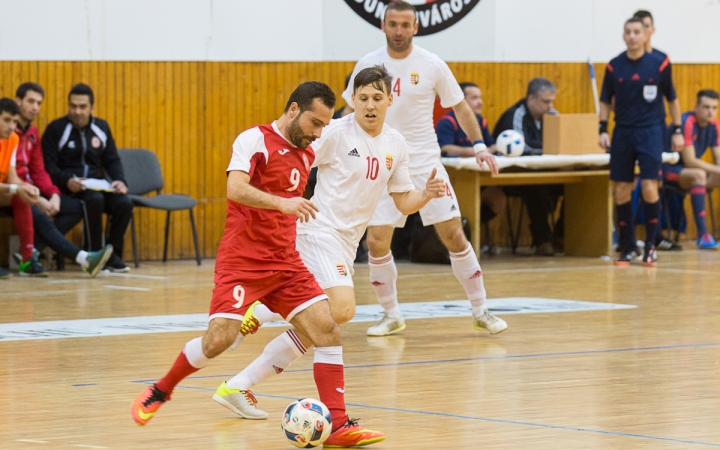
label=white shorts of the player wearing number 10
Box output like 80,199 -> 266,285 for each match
295,231 -> 355,289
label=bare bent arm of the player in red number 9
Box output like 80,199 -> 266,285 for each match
227,170 -> 318,222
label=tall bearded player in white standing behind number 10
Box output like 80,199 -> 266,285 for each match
343,1 -> 507,336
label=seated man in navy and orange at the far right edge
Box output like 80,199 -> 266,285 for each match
656,89 -> 720,249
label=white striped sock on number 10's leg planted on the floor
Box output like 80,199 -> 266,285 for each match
226,330 -> 307,391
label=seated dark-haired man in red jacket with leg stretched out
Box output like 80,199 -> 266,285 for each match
15,83 -> 112,276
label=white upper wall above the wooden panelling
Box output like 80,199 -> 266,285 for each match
0,0 -> 720,63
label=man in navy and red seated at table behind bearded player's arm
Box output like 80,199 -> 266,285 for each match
435,82 -> 507,222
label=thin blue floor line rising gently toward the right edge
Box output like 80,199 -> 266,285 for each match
131,342 -> 720,383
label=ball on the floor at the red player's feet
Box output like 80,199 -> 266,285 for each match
280,398 -> 332,448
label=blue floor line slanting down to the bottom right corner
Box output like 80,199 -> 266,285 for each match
163,386 -> 720,447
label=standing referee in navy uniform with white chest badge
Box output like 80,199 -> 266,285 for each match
599,17 -> 683,267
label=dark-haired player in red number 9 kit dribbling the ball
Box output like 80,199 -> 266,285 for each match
132,81 -> 385,442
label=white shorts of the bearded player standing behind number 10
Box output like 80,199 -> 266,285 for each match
366,165 -> 460,229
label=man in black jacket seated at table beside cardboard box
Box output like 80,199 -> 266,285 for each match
493,77 -> 563,256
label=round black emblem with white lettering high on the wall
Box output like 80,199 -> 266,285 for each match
345,0 -> 480,36
